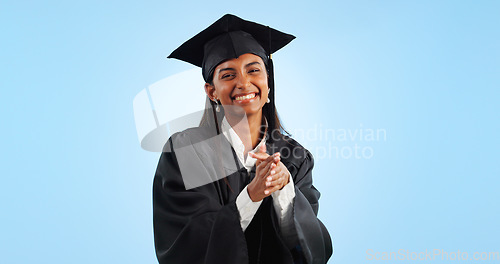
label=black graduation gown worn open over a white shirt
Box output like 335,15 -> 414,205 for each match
153,127 -> 332,264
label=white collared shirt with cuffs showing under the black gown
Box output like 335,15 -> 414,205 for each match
221,117 -> 295,236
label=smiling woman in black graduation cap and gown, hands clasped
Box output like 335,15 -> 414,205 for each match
153,15 -> 332,264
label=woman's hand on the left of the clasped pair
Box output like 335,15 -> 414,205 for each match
247,145 -> 280,202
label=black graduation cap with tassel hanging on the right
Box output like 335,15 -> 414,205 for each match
168,14 -> 295,141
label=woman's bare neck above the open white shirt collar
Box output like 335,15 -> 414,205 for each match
226,112 -> 262,155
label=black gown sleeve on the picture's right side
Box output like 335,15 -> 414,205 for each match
288,149 -> 333,264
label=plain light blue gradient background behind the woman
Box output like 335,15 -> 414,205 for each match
0,1 -> 500,264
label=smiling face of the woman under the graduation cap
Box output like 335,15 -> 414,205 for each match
205,53 -> 269,116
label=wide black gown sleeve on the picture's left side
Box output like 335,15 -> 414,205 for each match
153,137 -> 248,264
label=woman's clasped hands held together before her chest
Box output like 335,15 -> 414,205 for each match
247,144 -> 290,202
